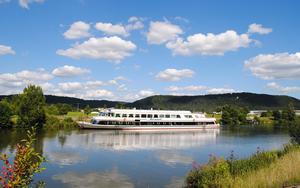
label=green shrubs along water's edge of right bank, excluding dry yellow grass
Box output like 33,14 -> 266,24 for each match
186,144 -> 300,187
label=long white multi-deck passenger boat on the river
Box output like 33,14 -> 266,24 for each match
78,108 -> 220,130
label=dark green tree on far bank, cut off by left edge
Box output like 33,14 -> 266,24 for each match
0,99 -> 13,128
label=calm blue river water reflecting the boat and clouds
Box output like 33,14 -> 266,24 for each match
0,130 -> 289,188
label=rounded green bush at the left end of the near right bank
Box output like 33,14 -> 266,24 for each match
186,156 -> 231,187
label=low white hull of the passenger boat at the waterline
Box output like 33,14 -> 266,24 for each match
78,122 -> 220,130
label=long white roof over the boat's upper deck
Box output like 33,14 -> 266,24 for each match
108,108 -> 192,114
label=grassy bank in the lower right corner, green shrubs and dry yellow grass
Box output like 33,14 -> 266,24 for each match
186,145 -> 300,188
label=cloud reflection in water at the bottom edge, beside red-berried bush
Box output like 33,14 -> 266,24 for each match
52,170 -> 134,188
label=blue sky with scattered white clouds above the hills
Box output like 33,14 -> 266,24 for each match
0,0 -> 300,101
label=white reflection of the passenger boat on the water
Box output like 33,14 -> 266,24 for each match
66,129 -> 219,150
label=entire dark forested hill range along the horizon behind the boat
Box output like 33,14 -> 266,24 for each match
0,93 -> 300,112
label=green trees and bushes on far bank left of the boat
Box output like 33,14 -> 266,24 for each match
0,85 -> 75,128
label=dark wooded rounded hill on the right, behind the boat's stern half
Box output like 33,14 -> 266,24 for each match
129,93 -> 300,111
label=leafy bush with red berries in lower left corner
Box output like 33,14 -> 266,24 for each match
0,129 -> 45,188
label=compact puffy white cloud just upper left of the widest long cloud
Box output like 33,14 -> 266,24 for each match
147,21 -> 183,44
